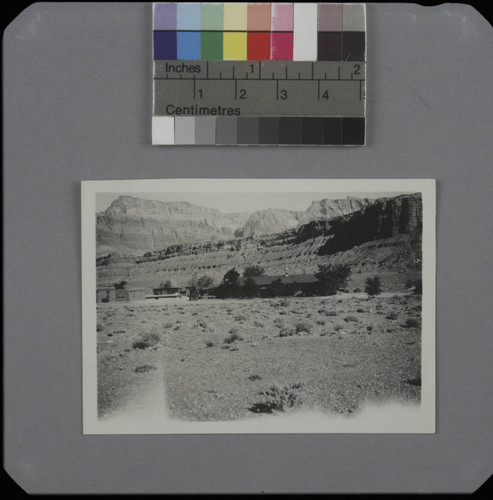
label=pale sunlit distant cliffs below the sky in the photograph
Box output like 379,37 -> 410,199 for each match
96,196 -> 369,255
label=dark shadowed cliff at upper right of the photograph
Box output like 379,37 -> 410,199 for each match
319,194 -> 423,255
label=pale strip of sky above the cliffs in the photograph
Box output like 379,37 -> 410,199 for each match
96,191 -> 409,213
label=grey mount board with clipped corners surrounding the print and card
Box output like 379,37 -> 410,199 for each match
3,2 -> 493,493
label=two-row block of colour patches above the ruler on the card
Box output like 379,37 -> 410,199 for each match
153,3 -> 366,61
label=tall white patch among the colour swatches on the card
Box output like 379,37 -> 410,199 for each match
293,3 -> 318,61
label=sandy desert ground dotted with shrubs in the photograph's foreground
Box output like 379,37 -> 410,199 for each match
97,293 -> 421,421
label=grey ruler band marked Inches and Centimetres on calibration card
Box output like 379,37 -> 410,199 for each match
153,60 -> 366,118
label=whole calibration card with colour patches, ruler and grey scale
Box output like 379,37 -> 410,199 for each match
152,3 -> 366,145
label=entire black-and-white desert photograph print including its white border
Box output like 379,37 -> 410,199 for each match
82,179 -> 435,434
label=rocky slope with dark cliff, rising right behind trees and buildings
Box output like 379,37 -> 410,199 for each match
97,194 -> 422,287
